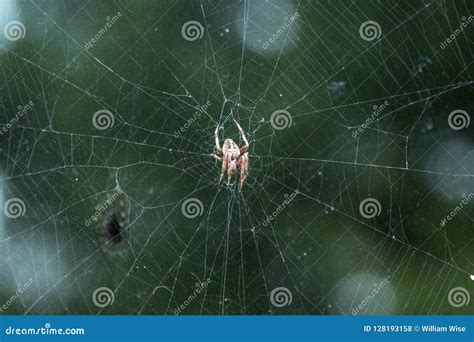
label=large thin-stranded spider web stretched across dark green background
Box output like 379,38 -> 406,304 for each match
0,0 -> 474,314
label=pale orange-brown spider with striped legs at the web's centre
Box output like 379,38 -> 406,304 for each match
212,120 -> 249,192
